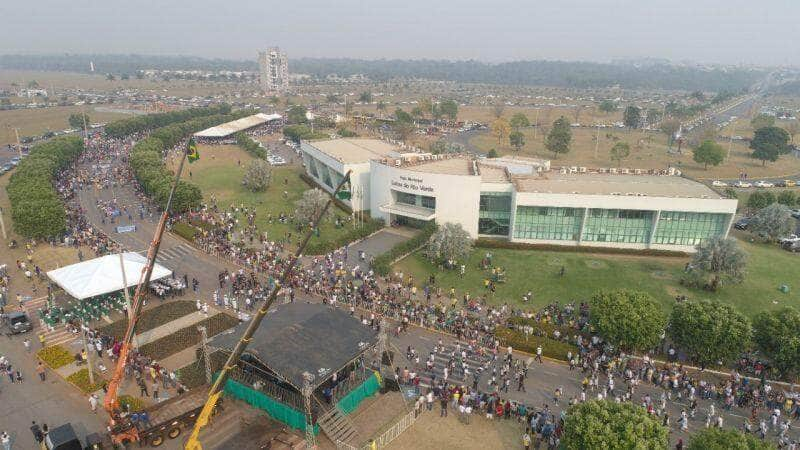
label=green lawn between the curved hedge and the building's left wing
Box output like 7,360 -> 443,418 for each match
166,145 -> 356,250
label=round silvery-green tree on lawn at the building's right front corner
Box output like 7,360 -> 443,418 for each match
690,237 -> 747,291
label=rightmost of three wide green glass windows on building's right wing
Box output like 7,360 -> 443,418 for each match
653,211 -> 730,245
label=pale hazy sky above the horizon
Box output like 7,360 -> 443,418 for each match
0,0 -> 800,65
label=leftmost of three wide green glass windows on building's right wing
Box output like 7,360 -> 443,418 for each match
514,206 -> 583,241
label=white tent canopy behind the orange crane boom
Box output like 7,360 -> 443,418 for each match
47,252 -> 172,300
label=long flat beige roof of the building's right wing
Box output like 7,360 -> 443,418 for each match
514,171 -> 722,199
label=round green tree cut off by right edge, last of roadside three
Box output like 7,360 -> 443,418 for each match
753,307 -> 800,377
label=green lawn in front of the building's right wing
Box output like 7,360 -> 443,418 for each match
394,242 -> 800,316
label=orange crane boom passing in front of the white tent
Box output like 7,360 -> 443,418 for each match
104,146 -> 186,444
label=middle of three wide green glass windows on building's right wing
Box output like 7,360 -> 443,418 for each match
583,209 -> 655,244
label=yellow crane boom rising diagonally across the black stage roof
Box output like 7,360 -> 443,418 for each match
185,170 -> 350,450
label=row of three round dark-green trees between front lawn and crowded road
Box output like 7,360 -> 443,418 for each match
590,290 -> 800,376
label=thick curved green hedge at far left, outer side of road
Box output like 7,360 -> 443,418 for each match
6,136 -> 84,238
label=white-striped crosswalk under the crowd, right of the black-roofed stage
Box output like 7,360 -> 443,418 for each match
412,343 -> 492,387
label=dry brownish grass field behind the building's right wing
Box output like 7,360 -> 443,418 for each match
470,128 -> 800,179
